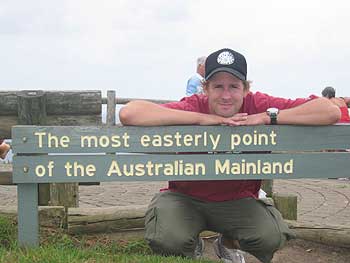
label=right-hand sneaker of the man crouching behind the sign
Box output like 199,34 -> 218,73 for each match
213,235 -> 245,263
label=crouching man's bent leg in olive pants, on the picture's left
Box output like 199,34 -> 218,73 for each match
145,192 -> 205,257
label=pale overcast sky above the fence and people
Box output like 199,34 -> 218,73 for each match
0,0 -> 350,100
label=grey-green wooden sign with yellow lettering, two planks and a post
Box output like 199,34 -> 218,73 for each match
12,125 -> 350,246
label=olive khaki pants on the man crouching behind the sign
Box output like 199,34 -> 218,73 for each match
145,191 -> 294,263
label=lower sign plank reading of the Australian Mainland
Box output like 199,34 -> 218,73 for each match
13,152 -> 350,183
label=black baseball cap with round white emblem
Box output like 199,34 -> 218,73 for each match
204,48 -> 247,80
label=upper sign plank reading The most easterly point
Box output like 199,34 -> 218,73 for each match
12,125 -> 350,153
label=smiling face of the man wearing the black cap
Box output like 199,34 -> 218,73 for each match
204,72 -> 249,117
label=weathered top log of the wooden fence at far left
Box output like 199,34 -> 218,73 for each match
0,90 -> 102,116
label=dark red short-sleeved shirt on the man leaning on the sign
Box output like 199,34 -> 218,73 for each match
162,92 -> 310,202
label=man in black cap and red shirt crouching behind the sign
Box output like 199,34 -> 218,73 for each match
119,49 -> 340,263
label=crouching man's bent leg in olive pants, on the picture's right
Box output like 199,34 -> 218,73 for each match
208,198 -> 294,263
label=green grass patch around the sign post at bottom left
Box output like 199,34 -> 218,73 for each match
0,217 -> 211,263
